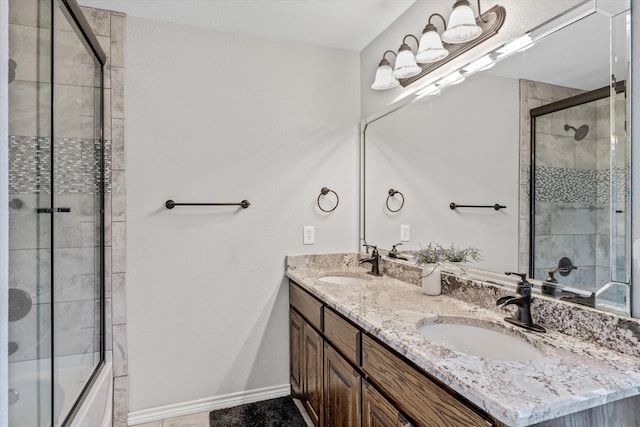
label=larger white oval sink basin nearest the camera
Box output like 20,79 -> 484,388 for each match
416,318 -> 544,362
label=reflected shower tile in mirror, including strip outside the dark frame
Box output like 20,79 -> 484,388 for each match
519,81 -> 628,291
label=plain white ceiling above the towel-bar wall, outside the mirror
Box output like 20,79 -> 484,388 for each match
78,0 -> 416,52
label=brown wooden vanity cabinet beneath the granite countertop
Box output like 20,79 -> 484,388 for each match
289,282 -> 492,427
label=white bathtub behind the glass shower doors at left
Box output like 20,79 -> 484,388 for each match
9,354 -> 113,427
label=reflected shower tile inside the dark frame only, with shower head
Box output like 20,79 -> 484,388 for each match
534,94 -> 609,291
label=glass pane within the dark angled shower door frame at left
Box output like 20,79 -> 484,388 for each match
51,0 -> 103,424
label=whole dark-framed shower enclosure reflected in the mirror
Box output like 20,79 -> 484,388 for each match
530,82 -> 631,312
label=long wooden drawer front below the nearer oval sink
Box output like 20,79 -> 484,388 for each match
362,335 -> 492,427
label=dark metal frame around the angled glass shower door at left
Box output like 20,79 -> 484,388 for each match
50,0 -> 107,426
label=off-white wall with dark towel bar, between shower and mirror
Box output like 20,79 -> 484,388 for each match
125,17 -> 360,412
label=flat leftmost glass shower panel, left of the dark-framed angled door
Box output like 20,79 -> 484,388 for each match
8,0 -> 56,427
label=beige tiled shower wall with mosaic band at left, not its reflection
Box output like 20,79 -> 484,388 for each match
9,0 -> 128,426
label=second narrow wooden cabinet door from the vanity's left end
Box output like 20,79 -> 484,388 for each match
302,323 -> 323,426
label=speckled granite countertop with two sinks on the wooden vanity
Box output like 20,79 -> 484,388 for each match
286,255 -> 640,427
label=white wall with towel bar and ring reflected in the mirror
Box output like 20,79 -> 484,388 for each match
365,74 -> 520,271
